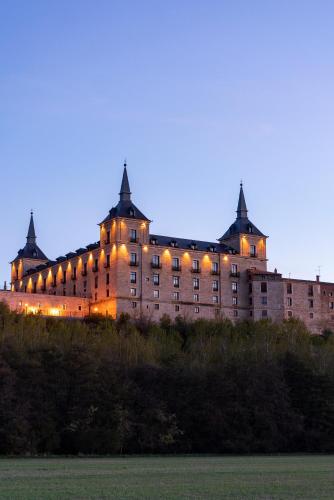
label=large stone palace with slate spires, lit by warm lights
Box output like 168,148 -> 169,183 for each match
0,165 -> 334,333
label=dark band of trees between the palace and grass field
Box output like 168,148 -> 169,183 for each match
0,304 -> 334,455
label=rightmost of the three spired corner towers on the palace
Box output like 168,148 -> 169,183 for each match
218,182 -> 267,262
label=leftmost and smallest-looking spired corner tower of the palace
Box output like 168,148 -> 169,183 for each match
11,212 -> 49,283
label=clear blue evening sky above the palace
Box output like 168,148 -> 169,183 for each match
0,0 -> 334,283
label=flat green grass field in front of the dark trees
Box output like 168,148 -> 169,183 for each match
0,455 -> 334,500
